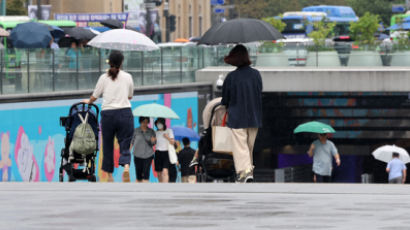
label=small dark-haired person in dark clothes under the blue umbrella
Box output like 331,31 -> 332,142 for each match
178,137 -> 196,183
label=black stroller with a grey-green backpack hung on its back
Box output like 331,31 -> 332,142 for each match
59,102 -> 99,182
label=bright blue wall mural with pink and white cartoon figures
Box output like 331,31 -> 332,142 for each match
0,92 -> 198,182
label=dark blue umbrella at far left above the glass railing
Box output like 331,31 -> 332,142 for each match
10,22 -> 51,48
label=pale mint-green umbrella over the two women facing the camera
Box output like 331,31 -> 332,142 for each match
132,103 -> 179,119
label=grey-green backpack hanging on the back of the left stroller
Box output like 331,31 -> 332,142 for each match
70,113 -> 97,155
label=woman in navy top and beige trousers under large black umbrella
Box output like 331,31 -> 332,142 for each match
221,45 -> 262,183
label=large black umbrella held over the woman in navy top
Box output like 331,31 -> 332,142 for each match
198,18 -> 283,45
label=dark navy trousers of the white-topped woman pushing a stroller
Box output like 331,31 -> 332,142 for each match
101,108 -> 134,173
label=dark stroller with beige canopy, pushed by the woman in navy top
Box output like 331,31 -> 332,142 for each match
197,98 -> 236,182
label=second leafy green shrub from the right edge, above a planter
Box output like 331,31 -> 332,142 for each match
350,12 -> 380,45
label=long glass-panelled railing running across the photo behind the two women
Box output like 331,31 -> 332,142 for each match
0,43 -> 410,94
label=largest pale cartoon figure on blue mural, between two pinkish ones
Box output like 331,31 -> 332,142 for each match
14,127 -> 40,181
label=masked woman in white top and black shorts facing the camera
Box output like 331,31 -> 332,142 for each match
154,118 -> 174,183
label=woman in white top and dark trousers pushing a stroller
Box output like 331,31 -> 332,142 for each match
83,51 -> 134,182
